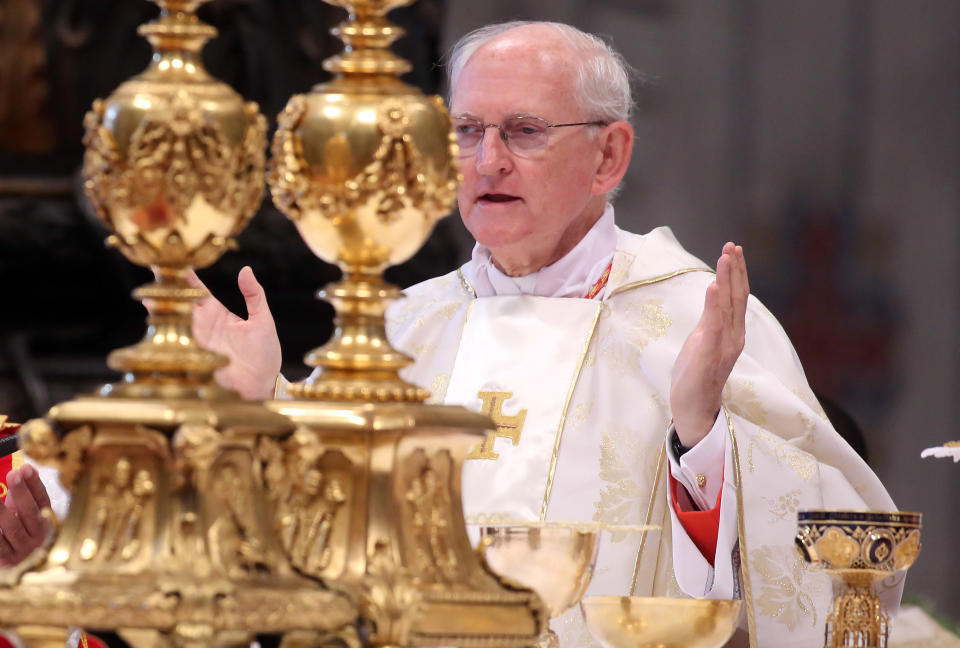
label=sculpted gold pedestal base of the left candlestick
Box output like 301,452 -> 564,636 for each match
0,395 -> 357,647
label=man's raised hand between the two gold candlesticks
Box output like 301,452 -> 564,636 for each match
188,266 -> 282,400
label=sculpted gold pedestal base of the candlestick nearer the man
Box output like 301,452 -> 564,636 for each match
265,400 -> 548,647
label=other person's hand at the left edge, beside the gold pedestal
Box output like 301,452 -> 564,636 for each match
0,466 -> 50,567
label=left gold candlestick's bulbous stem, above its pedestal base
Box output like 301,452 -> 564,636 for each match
83,0 -> 266,397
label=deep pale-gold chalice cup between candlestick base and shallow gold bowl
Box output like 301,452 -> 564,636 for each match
479,523 -> 600,618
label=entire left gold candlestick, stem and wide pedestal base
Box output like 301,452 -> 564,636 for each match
0,0 -> 359,648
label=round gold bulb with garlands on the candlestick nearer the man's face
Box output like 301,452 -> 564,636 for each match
270,78 -> 459,275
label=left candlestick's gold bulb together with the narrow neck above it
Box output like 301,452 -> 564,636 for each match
83,0 -> 266,268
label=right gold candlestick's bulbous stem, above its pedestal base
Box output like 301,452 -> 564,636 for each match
268,0 -> 459,402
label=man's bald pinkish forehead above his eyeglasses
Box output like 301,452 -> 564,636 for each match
451,26 -> 576,119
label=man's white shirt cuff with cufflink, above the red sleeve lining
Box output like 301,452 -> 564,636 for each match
665,410 -> 727,511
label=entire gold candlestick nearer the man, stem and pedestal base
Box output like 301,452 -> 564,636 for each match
260,0 -> 547,647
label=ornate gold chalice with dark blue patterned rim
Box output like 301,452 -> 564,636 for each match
796,511 -> 921,648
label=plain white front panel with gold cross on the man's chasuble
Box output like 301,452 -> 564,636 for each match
444,295 -> 601,522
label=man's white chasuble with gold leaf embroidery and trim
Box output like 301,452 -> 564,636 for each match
388,228 -> 896,648
